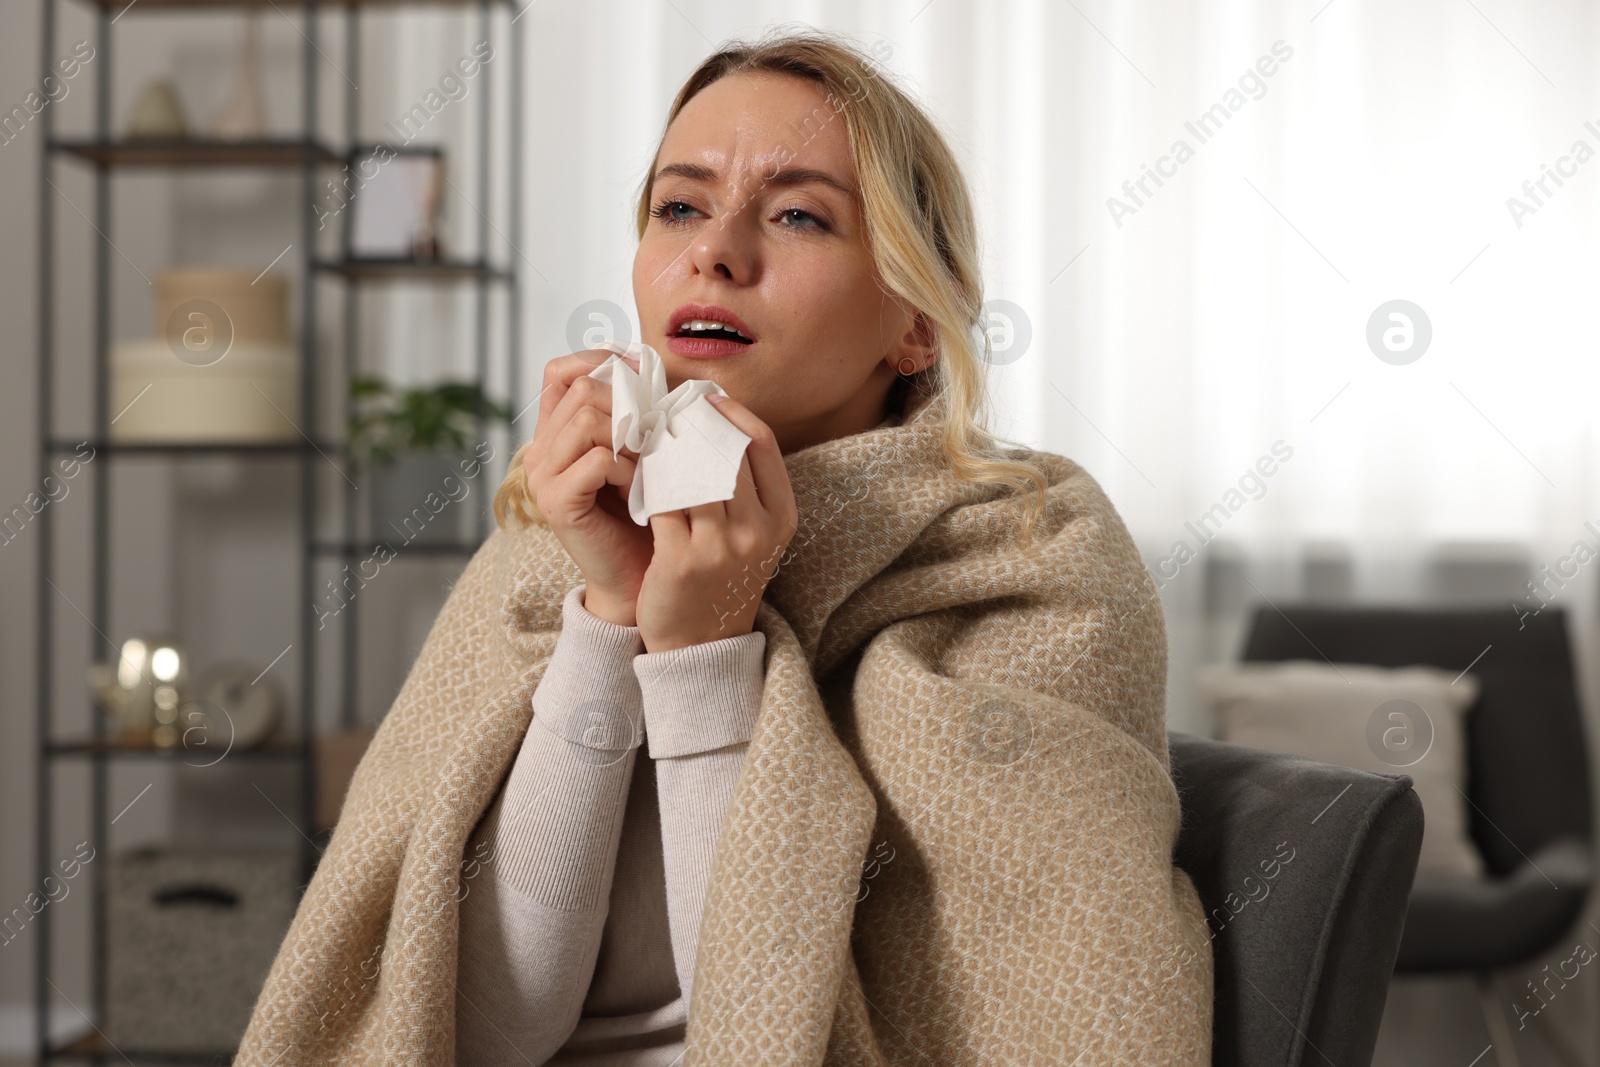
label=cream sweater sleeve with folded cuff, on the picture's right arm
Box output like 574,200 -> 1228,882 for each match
634,630 -> 766,1003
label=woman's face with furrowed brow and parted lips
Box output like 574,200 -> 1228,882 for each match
634,72 -> 933,453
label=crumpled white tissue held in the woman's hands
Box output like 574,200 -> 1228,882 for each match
589,341 -> 750,526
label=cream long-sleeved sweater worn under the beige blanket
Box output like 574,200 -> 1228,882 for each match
456,585 -> 766,1067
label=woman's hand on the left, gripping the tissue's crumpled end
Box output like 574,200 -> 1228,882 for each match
523,349 -> 654,625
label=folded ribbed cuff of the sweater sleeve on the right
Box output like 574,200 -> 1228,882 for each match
634,630 -> 766,760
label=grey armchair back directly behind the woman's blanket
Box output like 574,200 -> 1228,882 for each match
1170,731 -> 1422,1067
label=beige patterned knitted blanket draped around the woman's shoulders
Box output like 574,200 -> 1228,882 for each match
234,391 -> 1213,1067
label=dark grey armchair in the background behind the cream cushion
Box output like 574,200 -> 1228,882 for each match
1243,606 -> 1595,1067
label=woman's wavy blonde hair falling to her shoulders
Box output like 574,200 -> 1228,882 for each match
494,27 -> 1048,539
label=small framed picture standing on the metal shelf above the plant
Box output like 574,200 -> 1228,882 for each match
344,144 -> 445,262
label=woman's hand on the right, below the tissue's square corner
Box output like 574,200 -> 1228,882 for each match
638,397 -> 798,653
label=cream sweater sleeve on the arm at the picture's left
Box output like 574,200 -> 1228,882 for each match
456,585 -> 643,1067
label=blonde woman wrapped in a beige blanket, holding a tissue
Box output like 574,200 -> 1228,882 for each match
238,24 -> 1211,1065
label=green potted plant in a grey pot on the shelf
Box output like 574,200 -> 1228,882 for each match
347,374 -> 510,547
